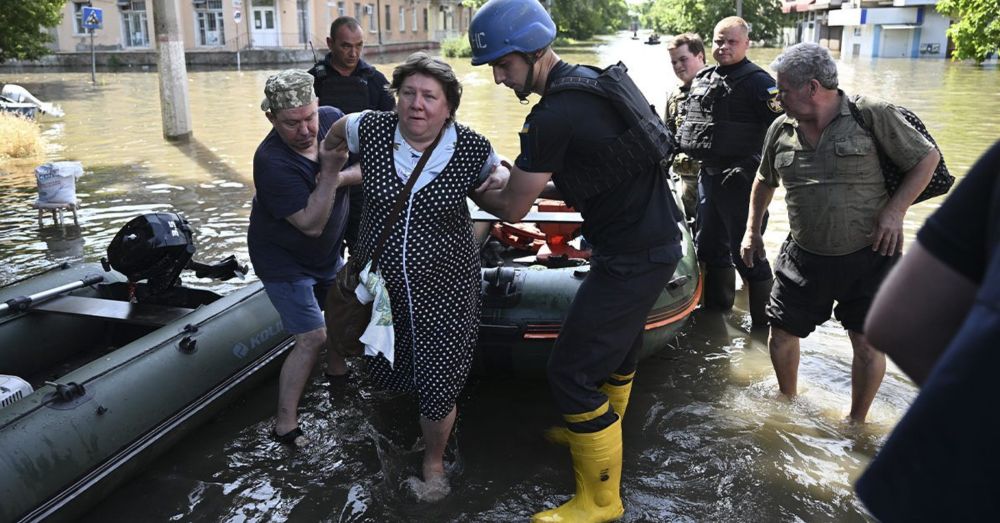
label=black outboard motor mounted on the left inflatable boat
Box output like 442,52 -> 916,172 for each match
105,212 -> 247,295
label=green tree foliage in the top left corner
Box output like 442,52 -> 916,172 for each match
0,0 -> 66,64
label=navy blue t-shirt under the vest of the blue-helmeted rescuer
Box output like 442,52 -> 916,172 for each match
515,62 -> 682,258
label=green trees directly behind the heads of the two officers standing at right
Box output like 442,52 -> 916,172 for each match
642,0 -> 788,46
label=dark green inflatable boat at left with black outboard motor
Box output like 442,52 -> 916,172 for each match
0,213 -> 292,521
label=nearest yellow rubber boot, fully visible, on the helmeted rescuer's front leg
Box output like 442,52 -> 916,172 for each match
531,418 -> 625,523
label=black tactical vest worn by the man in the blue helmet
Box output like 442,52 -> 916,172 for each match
545,62 -> 674,211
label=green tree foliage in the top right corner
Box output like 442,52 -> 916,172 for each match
937,0 -> 1000,64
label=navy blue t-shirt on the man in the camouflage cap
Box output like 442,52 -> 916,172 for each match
247,107 -> 348,281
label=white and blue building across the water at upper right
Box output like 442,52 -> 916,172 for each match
782,0 -> 952,58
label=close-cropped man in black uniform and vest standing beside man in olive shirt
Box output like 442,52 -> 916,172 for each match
678,16 -> 782,326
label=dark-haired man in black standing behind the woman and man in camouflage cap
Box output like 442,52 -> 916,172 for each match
309,16 -> 396,248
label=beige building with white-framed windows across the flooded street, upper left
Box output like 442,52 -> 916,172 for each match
51,0 -> 472,61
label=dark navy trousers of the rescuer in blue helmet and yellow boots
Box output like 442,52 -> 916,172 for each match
547,244 -> 681,432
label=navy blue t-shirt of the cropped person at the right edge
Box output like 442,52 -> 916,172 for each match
856,142 -> 1000,523
